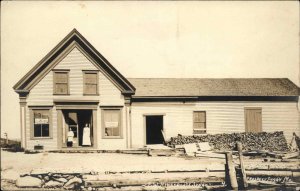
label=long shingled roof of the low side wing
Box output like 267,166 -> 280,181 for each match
128,78 -> 299,97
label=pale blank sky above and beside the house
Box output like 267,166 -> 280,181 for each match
1,1 -> 300,138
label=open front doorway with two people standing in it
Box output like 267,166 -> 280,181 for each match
63,110 -> 93,147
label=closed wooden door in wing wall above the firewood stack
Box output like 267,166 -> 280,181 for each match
245,108 -> 262,133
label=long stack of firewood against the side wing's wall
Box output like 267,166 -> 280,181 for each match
167,131 -> 289,151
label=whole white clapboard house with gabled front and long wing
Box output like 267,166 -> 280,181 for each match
13,29 -> 300,150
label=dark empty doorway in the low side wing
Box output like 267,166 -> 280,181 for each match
146,115 -> 164,144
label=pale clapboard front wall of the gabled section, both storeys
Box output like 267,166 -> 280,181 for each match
26,47 -> 126,150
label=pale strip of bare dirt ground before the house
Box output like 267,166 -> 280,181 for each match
1,151 -> 225,180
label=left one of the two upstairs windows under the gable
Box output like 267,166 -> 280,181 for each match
53,70 -> 69,95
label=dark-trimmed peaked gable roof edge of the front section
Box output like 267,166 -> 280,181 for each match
13,29 -> 135,94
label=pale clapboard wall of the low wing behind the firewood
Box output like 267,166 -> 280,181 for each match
131,102 -> 300,147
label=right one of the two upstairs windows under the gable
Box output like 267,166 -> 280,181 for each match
83,71 -> 98,95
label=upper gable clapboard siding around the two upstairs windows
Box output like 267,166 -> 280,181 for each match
27,48 -> 124,105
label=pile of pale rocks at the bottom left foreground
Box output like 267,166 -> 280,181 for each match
16,173 -> 83,190
